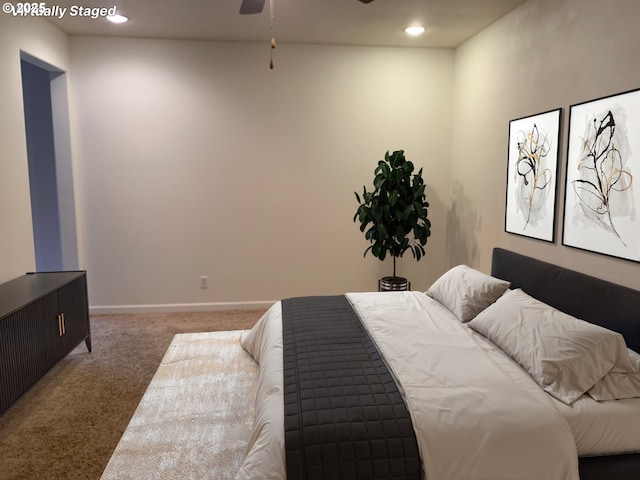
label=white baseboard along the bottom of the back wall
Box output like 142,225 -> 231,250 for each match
89,300 -> 276,315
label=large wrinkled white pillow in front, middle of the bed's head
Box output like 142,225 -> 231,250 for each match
469,289 -> 628,404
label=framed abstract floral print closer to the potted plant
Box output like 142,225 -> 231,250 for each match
505,108 -> 562,242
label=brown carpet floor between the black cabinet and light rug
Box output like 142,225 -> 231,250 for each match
0,310 -> 264,480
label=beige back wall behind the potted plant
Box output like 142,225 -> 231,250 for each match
70,37 -> 453,310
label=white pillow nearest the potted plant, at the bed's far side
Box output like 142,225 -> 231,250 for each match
426,265 -> 510,322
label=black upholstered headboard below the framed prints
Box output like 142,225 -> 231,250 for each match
491,248 -> 640,352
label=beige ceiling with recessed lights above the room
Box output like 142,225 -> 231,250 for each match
49,0 -> 526,48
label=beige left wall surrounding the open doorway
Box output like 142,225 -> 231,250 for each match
0,14 -> 69,283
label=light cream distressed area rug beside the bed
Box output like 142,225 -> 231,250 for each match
101,330 -> 258,480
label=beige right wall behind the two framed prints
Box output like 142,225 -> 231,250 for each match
447,0 -> 640,289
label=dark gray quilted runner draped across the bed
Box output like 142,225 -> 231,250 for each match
282,295 -> 421,480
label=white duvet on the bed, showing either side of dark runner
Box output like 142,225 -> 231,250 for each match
236,292 -> 578,480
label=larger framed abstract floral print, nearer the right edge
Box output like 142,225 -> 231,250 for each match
562,89 -> 640,262
